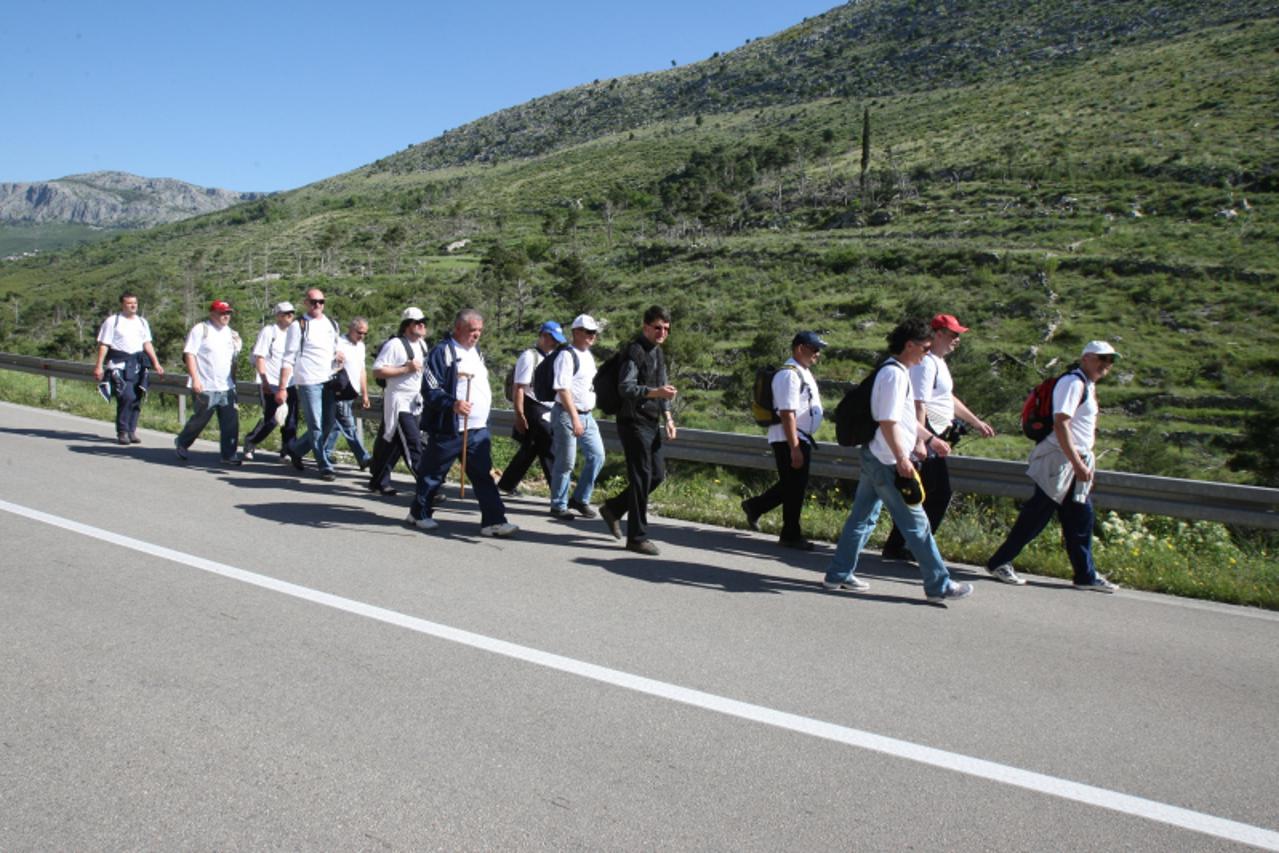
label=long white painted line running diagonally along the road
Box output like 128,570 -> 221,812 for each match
0,500 -> 1279,850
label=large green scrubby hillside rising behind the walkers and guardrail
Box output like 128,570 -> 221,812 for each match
0,1 -> 1279,480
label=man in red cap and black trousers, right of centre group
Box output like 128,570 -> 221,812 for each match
884,313 -> 995,560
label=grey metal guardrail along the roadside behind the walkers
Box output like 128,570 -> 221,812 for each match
0,353 -> 1279,529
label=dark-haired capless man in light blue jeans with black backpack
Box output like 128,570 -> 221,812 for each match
821,320 -> 972,602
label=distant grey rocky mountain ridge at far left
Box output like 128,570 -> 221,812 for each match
0,171 -> 266,229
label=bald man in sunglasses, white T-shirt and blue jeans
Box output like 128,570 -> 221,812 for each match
275,288 -> 340,480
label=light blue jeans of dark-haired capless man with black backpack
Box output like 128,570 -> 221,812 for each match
826,448 -> 950,596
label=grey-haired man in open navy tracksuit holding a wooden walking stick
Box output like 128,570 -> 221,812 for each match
407,308 -> 519,537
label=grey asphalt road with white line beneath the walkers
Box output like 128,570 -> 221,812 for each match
0,404 -> 1279,850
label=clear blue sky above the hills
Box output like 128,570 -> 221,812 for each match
0,0 -> 838,191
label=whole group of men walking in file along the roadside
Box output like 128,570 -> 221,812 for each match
95,288 -> 1117,602
